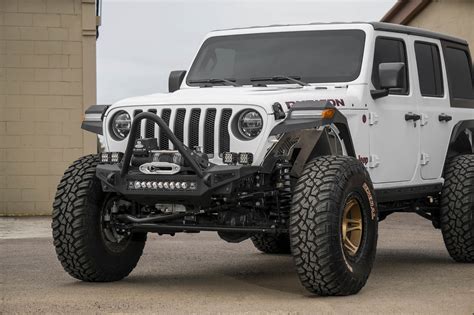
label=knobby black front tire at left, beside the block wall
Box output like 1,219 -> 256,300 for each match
52,155 -> 146,282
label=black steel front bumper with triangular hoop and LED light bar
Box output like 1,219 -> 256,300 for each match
96,112 -> 262,206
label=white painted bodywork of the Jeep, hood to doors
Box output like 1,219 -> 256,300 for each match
103,24 -> 474,195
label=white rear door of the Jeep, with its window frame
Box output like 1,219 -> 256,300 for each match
412,36 -> 453,179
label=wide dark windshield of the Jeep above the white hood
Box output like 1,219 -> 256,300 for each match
186,30 -> 365,86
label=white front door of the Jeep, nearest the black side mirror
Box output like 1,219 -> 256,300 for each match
369,33 -> 420,183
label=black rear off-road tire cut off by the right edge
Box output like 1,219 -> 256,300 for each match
440,154 -> 474,263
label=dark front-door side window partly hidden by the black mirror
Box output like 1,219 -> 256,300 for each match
372,37 -> 408,94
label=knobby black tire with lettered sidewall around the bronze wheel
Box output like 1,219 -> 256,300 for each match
290,156 -> 378,296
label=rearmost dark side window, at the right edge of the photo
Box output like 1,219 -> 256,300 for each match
444,46 -> 474,99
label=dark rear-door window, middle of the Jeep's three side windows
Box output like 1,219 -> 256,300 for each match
415,42 -> 444,97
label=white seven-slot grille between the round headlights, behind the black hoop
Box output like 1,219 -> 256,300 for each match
133,105 -> 232,157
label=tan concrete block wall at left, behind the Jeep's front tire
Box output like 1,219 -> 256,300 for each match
0,0 -> 96,215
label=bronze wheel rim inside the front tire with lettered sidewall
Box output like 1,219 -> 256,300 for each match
341,198 -> 363,257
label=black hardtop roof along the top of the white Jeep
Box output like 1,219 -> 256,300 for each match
214,22 -> 468,46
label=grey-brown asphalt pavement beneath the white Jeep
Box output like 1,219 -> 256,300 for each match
0,214 -> 474,314
